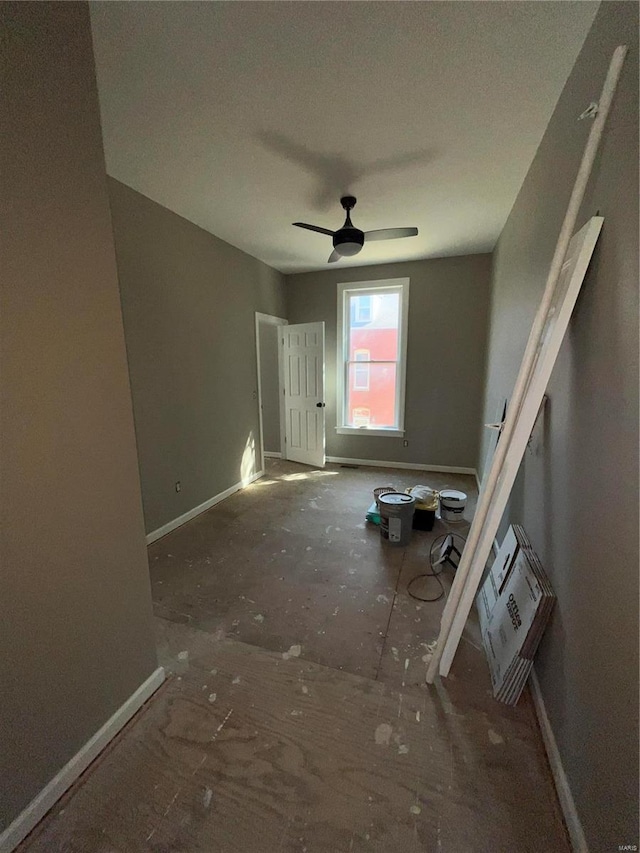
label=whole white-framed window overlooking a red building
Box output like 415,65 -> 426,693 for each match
336,279 -> 409,436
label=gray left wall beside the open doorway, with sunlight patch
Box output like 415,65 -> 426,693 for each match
109,179 -> 285,532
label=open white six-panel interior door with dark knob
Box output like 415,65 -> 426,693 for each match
282,323 -> 325,467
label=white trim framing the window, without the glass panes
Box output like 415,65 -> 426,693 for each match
335,278 -> 409,438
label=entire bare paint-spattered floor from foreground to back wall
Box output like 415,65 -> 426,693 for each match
23,461 -> 569,853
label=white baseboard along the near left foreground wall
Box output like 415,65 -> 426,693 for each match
0,666 -> 164,853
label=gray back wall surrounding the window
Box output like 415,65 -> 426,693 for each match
286,255 -> 491,468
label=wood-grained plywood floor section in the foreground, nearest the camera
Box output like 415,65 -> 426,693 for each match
20,620 -> 567,853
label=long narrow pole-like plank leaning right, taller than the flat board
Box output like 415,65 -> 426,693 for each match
427,45 -> 627,683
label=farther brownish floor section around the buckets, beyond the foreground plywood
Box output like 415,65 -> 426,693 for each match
149,460 -> 476,678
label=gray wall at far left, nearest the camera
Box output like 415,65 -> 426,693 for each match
0,3 -> 157,832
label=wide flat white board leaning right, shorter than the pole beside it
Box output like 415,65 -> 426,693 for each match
440,216 -> 604,676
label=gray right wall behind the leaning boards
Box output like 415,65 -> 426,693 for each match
480,2 -> 638,851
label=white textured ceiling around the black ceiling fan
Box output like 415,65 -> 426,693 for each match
91,0 -> 597,272
